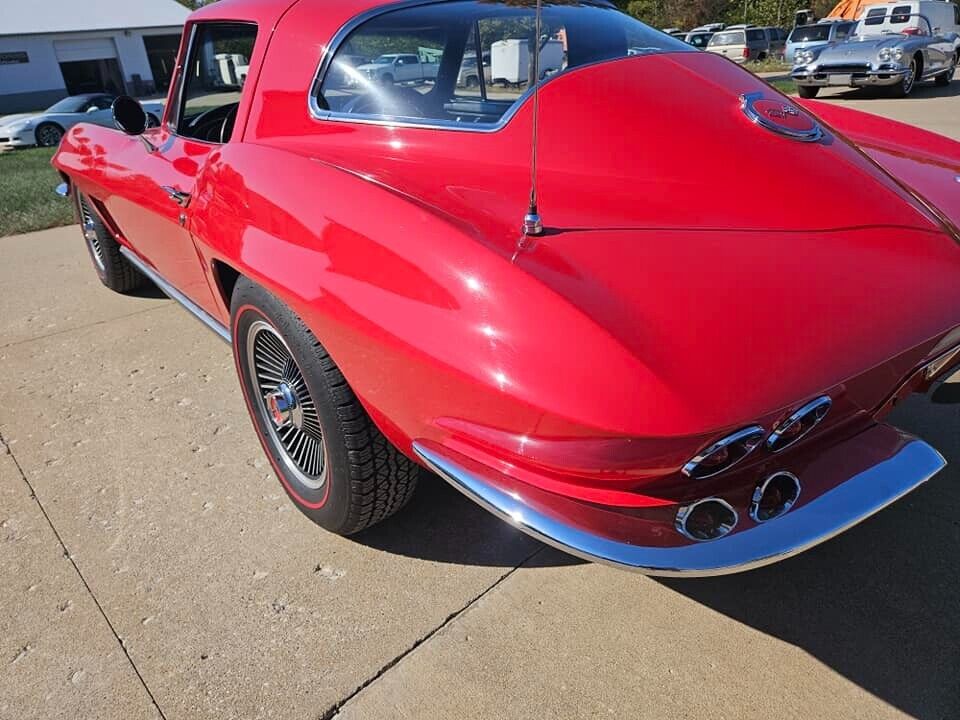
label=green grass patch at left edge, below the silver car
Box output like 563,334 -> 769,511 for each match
0,148 -> 74,237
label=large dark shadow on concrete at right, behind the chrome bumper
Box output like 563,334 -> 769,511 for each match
661,398 -> 960,718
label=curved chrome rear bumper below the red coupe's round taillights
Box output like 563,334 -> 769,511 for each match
413,440 -> 946,577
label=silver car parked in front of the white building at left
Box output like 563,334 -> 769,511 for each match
0,93 -> 163,150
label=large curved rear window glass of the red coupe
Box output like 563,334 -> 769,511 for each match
314,0 -> 694,127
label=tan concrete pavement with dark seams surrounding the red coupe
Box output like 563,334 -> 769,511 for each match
0,97 -> 960,720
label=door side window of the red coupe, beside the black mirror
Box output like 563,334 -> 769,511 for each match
172,23 -> 257,142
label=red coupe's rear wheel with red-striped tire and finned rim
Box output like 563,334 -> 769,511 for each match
231,278 -> 419,535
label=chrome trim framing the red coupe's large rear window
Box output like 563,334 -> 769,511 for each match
307,0 -> 697,133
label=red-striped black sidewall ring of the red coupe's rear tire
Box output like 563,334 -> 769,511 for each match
231,280 -> 350,532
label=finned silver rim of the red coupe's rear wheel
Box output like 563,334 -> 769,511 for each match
246,320 -> 327,490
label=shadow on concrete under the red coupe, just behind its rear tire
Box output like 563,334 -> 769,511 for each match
350,470 -> 583,567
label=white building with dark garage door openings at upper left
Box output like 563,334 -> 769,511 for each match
0,0 -> 189,115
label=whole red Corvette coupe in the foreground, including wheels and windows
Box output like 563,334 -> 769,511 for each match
54,0 -> 960,575
